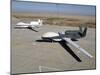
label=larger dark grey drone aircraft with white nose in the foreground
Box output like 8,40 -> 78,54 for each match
41,27 -> 93,62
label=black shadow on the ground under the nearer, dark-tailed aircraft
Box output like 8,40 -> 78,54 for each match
36,40 -> 82,62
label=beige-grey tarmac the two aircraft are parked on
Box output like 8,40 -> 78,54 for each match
11,24 -> 96,74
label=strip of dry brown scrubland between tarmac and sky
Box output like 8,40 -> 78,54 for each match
12,13 -> 96,28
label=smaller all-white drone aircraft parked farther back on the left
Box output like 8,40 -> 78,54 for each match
15,19 -> 43,32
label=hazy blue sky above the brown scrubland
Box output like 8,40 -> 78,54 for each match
12,1 -> 96,16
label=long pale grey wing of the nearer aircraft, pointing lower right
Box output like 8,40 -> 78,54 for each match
59,33 -> 93,58
